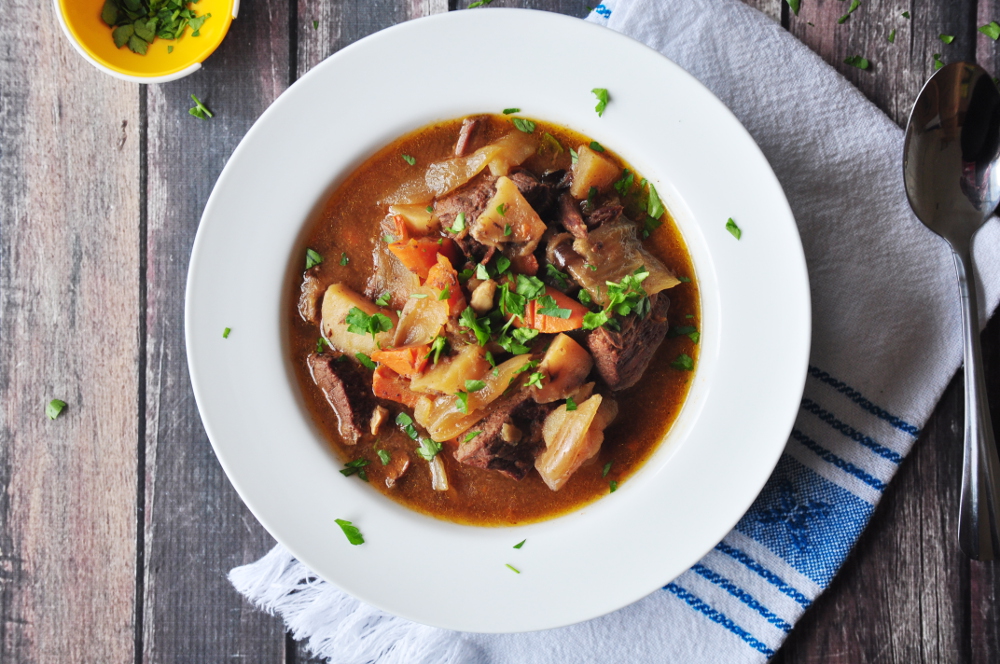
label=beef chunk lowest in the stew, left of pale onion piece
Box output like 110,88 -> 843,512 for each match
455,389 -> 557,480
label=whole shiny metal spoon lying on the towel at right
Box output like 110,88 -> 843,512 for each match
903,62 -> 1000,560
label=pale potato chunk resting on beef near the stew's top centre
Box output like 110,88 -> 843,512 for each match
470,176 -> 546,256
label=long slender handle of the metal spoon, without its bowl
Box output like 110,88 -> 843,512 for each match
955,248 -> 1000,560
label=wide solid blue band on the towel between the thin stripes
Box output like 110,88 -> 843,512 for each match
736,454 -> 874,587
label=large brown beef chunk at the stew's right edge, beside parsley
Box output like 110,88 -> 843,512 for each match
587,293 -> 670,390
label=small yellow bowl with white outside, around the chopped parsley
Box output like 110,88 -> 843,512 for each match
55,0 -> 240,83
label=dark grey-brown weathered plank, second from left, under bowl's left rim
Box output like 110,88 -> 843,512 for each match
143,0 -> 290,664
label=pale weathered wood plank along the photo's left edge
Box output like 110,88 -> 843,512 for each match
0,0 -> 140,664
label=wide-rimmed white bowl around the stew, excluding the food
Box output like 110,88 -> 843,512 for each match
186,9 -> 810,632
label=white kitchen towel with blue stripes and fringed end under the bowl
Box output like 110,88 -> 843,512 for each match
230,0 -> 1000,664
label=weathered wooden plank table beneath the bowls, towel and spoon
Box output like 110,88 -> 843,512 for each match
0,0 -> 1000,664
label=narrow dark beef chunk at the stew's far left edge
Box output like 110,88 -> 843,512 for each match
306,353 -> 378,445
